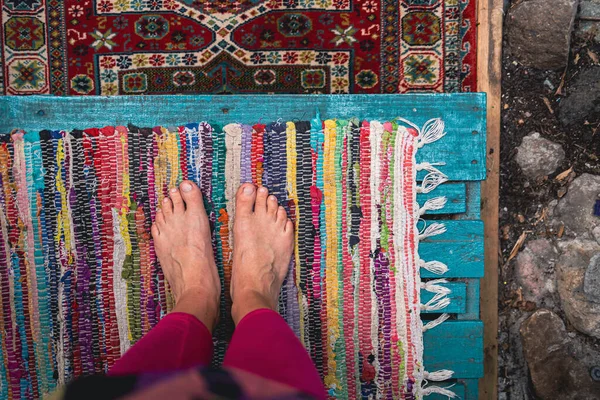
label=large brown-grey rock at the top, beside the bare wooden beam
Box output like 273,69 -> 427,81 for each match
505,0 -> 579,69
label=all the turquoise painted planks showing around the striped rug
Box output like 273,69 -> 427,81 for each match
0,93 -> 486,400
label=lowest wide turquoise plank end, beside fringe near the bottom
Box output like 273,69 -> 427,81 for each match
423,321 -> 483,378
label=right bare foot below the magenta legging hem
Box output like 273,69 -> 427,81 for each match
231,183 -> 294,325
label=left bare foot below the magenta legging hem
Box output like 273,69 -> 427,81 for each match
152,181 -> 221,332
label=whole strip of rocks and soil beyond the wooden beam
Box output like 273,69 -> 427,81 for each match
499,0 -> 600,400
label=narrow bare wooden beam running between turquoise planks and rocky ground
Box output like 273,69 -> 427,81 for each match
477,0 -> 504,400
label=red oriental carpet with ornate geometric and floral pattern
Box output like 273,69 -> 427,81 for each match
0,0 -> 476,95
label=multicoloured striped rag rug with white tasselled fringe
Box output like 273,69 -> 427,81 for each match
0,118 -> 451,399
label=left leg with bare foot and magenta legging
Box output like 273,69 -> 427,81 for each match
109,181 -> 221,375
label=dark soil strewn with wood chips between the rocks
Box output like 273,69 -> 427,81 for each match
498,24 -> 600,399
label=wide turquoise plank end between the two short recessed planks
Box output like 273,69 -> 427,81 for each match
419,220 -> 483,278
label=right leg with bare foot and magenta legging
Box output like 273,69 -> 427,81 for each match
223,184 -> 326,399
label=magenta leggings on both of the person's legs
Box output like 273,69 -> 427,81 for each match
108,309 -> 326,399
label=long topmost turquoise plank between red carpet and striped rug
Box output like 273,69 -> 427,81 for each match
0,93 -> 486,181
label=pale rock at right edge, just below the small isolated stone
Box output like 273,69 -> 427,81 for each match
554,174 -> 600,237
